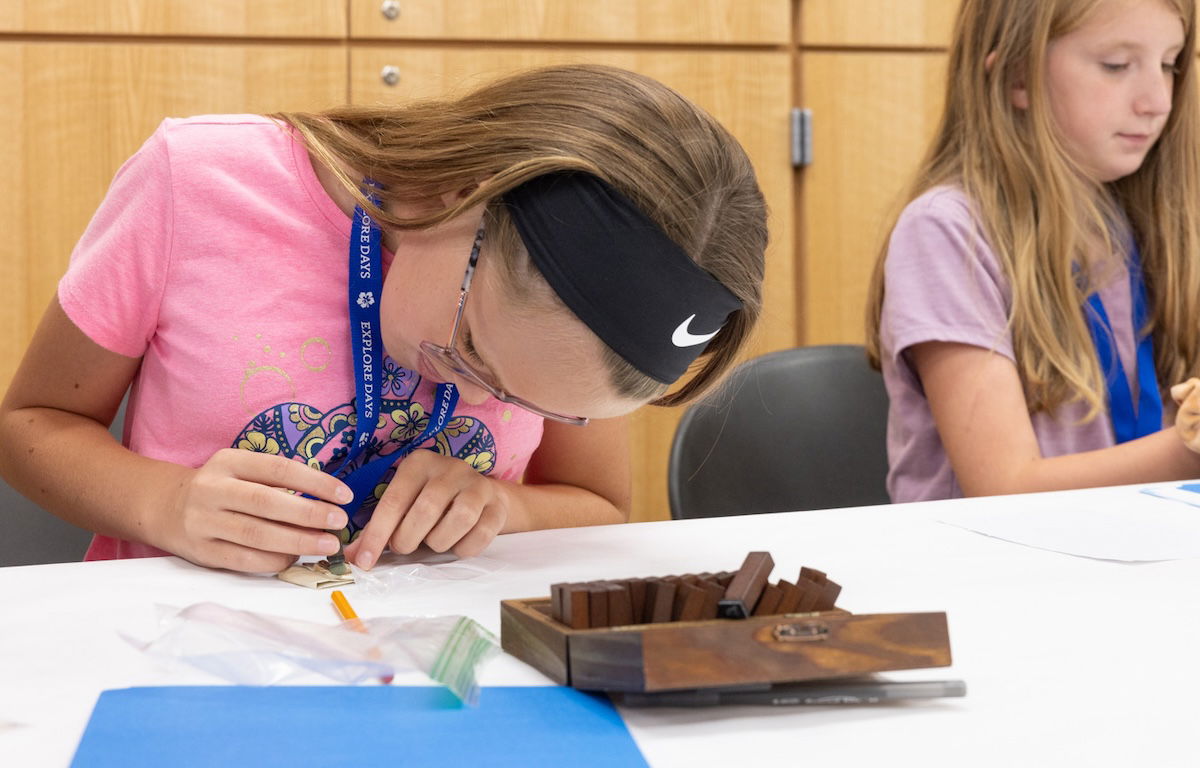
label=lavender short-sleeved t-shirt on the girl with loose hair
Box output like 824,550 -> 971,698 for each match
880,186 -> 1174,502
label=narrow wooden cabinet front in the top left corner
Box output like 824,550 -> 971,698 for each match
0,0 -> 346,37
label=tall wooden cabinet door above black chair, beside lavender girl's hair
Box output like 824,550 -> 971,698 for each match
799,49 -> 946,344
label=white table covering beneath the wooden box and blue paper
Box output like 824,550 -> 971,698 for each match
0,488 -> 1200,768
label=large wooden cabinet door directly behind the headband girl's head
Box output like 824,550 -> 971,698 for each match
350,46 -> 797,520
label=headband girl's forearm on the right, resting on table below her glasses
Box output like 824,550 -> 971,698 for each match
496,480 -> 629,533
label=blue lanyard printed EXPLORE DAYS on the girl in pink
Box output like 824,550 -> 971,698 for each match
338,181 -> 458,534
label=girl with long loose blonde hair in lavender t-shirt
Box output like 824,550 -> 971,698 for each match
868,0 -> 1200,502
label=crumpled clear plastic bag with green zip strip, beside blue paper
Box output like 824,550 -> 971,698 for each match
125,602 -> 499,706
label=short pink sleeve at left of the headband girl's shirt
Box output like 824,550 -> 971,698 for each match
59,122 -> 173,358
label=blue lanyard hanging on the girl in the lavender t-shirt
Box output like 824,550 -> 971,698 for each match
1084,244 -> 1163,443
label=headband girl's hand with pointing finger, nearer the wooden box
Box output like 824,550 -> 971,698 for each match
346,450 -> 509,569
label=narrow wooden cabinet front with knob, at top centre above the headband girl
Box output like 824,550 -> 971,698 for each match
350,0 -> 791,44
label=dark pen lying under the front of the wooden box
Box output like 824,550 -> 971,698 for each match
611,680 -> 967,707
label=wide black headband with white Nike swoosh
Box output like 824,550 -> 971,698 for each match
504,172 -> 742,384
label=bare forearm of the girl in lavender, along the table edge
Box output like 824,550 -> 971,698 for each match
959,428 -> 1200,496
